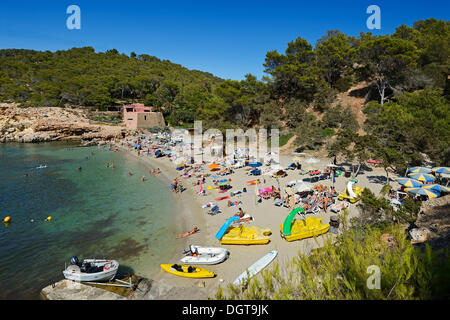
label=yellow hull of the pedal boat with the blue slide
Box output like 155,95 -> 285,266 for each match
220,224 -> 272,244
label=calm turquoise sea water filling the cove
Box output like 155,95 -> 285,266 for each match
0,142 -> 179,299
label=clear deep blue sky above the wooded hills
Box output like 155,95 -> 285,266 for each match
0,0 -> 450,80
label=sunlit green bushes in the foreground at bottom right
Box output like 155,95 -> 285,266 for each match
215,210 -> 450,300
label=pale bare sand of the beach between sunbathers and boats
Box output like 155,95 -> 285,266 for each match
107,136 -> 384,299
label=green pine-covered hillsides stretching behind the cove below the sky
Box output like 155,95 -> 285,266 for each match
0,19 -> 450,166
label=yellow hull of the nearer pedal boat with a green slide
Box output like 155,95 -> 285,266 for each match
280,217 -> 330,241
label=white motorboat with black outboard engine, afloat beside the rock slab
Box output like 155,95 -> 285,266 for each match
63,257 -> 119,282
